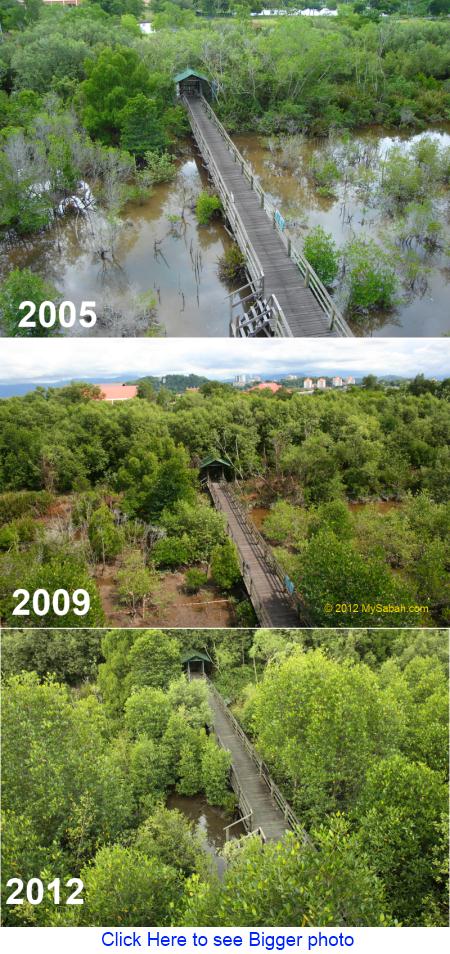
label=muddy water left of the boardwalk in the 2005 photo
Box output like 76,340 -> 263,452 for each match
0,154 -> 237,337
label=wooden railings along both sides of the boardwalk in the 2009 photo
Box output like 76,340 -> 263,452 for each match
206,477 -> 311,629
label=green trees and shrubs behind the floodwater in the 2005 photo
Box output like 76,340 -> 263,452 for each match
0,0 -> 450,238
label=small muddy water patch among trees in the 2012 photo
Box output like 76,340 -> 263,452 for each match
167,795 -> 245,874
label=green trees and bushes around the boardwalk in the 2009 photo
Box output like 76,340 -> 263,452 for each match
0,379 -> 450,626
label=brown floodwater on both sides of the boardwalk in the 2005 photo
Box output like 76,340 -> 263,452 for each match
0,129 -> 450,337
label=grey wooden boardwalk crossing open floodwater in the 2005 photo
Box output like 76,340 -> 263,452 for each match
186,97 -> 351,337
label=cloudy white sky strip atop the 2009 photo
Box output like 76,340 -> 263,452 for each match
0,338 -> 450,385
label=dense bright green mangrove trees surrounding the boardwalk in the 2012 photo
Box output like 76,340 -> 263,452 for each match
2,629 -> 448,926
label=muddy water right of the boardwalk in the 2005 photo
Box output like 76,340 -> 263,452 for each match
234,129 -> 450,337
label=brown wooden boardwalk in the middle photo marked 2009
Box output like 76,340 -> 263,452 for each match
208,482 -> 301,629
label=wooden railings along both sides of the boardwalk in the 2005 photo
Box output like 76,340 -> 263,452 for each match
184,96 -> 353,338
